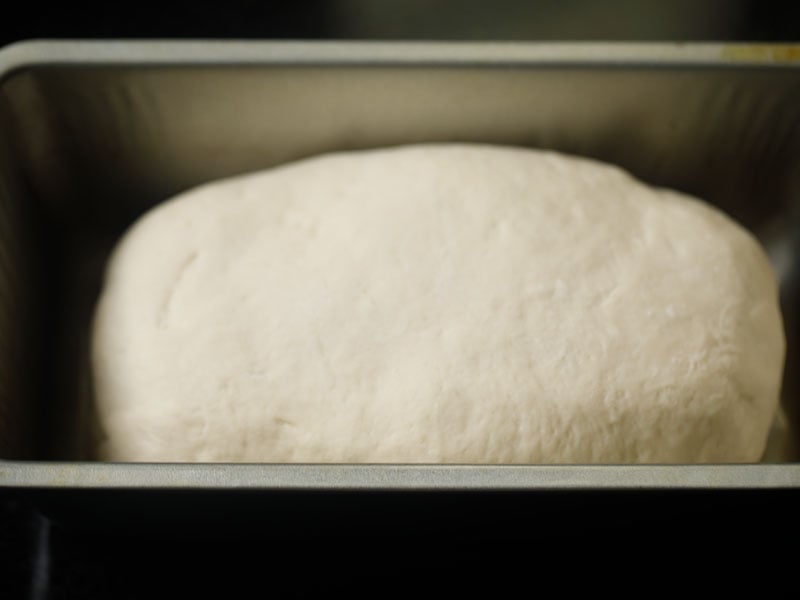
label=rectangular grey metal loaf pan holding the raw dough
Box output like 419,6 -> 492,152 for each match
0,41 -> 800,524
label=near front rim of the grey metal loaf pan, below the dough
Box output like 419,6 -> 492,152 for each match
0,462 -> 800,491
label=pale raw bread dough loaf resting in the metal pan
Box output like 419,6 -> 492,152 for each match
92,144 -> 785,463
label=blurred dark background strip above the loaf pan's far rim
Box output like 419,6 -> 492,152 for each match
0,0 -> 800,45
